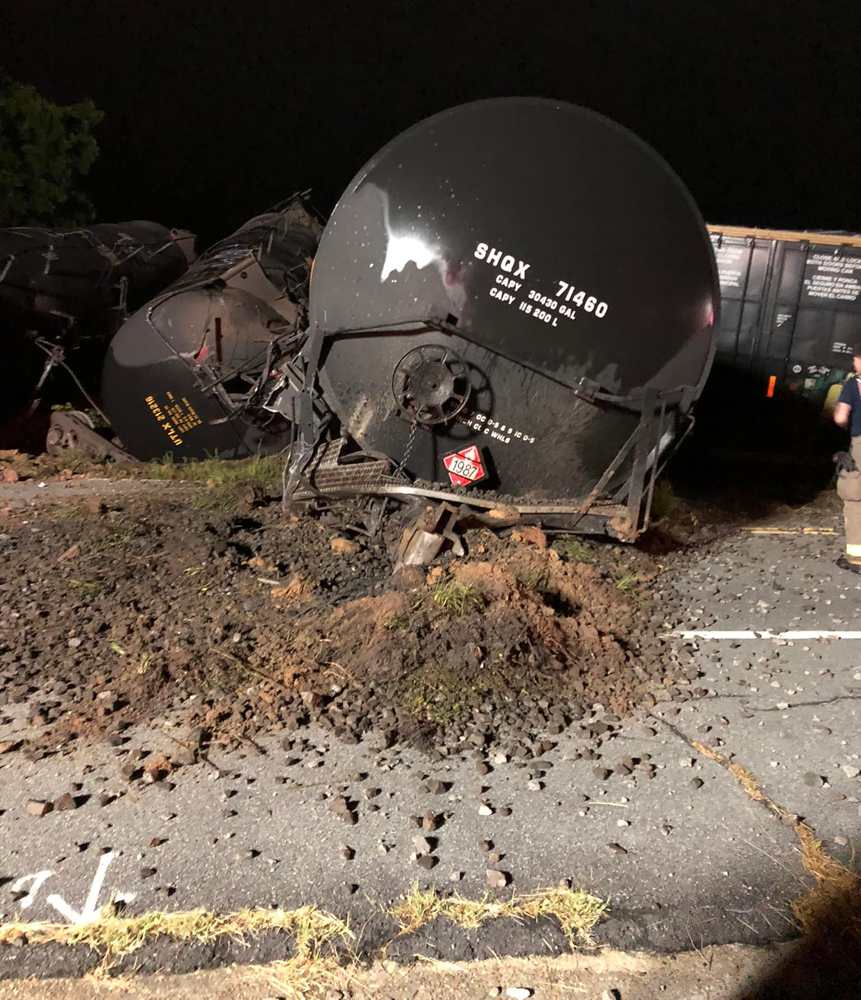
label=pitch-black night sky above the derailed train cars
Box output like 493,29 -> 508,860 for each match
0,0 -> 861,242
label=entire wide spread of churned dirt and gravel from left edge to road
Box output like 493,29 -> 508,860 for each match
0,489 -> 658,747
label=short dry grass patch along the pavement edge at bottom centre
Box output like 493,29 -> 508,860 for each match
388,885 -> 608,947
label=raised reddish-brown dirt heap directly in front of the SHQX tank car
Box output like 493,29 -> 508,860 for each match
262,533 -> 645,742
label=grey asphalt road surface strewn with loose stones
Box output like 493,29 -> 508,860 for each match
0,486 -> 861,976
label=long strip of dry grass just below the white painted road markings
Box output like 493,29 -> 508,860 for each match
0,903 -> 352,972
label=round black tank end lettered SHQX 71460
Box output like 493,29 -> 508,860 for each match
310,98 -> 719,496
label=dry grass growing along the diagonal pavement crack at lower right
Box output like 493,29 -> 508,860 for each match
691,742 -> 861,942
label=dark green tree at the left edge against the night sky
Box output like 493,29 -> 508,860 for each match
0,77 -> 104,228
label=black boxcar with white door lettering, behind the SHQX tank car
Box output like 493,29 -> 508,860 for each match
699,226 -> 861,459
